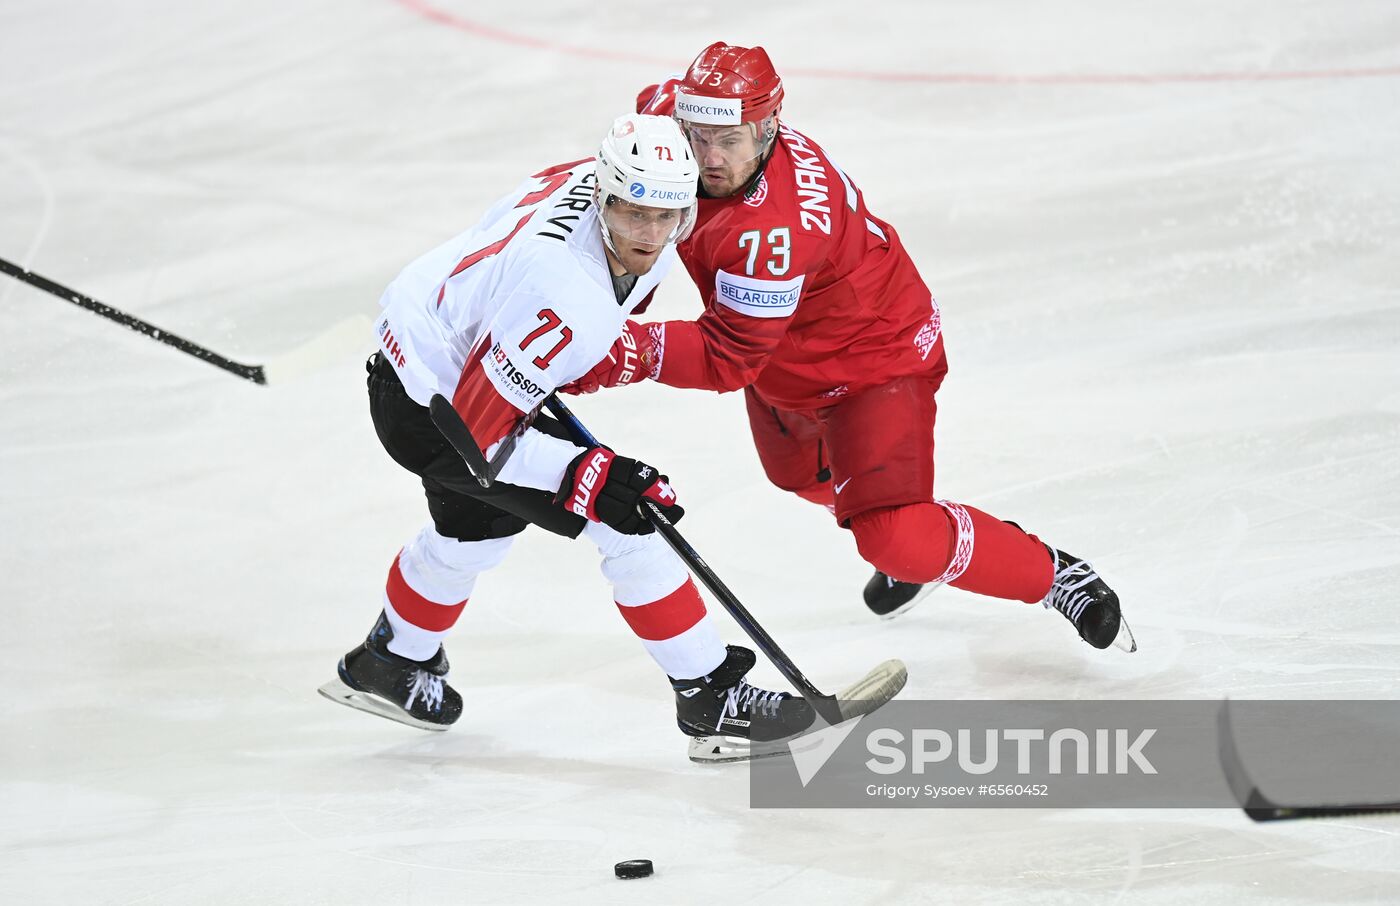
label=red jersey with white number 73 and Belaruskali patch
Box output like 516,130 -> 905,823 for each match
654,126 -> 946,409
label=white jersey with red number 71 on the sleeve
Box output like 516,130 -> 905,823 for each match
377,158 -> 676,490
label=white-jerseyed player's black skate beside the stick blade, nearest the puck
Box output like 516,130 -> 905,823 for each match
671,646 -> 816,763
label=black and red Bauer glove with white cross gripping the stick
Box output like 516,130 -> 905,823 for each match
554,447 -> 686,535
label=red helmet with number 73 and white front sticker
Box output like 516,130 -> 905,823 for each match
676,41 -> 783,126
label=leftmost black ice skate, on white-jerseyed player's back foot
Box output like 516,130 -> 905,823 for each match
321,613 -> 462,730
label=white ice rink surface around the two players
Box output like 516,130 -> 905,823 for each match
0,0 -> 1400,905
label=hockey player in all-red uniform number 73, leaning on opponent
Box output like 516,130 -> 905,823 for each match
571,42 -> 1135,650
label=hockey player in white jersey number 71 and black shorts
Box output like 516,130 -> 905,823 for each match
321,115 -> 811,761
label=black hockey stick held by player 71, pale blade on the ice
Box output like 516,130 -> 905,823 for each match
545,396 -> 909,724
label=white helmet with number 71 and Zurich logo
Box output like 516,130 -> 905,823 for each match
595,113 -> 700,253
